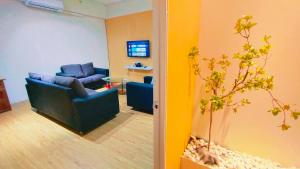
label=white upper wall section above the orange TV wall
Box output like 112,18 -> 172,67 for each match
106,0 -> 152,18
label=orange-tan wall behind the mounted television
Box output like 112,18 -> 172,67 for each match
106,11 -> 153,81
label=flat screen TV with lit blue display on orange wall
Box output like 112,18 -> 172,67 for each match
127,40 -> 150,58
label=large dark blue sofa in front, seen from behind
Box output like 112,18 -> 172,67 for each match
26,78 -> 120,134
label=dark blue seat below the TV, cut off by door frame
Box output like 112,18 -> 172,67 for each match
126,76 -> 153,113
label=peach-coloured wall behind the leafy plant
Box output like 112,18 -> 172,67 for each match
193,0 -> 300,167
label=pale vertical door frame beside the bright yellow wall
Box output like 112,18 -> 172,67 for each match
153,0 -> 168,169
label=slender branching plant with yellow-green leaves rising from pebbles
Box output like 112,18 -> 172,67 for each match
189,16 -> 300,151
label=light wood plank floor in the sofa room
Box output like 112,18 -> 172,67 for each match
0,96 -> 153,169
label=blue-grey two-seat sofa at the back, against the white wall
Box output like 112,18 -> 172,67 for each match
56,62 -> 109,89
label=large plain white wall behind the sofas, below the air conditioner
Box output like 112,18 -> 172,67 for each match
0,0 -> 109,103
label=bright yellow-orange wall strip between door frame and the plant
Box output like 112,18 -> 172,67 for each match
166,0 -> 200,169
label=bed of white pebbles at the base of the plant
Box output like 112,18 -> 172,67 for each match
184,137 -> 297,169
